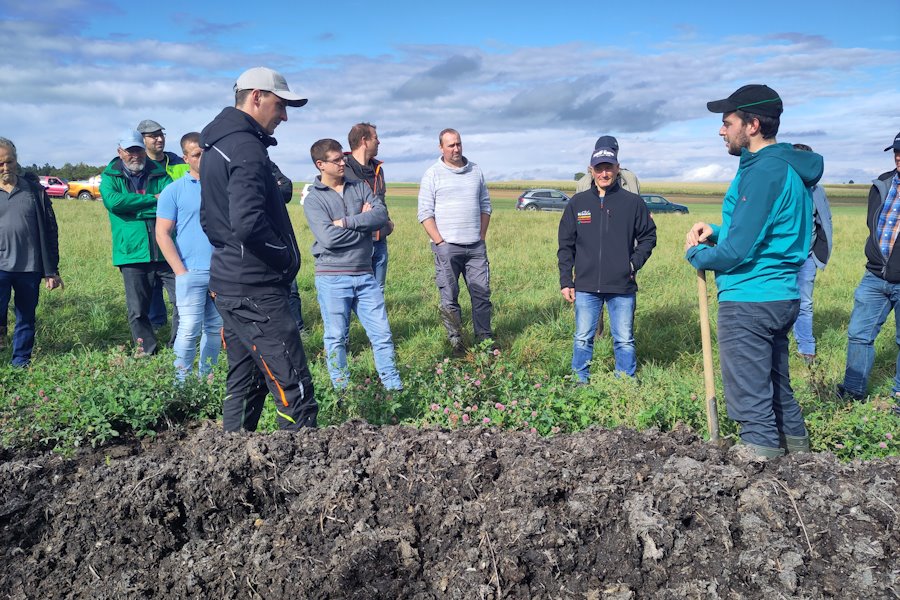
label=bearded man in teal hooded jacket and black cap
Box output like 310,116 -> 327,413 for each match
685,84 -> 823,457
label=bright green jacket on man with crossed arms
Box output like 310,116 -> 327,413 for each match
100,158 -> 172,266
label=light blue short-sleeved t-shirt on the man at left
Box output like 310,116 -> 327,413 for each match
156,173 -> 213,271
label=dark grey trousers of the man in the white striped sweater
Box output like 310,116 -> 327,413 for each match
431,240 -> 493,341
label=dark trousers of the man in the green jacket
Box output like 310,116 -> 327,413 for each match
119,261 -> 178,354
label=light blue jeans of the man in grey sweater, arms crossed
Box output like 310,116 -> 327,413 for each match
316,273 -> 403,390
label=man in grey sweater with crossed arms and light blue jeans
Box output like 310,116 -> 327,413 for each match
303,139 -> 403,390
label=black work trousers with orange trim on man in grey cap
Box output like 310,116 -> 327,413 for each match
215,288 -> 319,431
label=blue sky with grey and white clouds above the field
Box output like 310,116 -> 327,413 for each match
0,0 -> 900,183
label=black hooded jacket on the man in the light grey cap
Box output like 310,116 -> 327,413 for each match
200,107 -> 300,296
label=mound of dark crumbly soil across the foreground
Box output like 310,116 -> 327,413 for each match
0,422 -> 900,599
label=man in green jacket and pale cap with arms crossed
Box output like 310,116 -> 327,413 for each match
100,129 -> 175,354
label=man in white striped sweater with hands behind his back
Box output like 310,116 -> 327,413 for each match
418,129 -> 496,356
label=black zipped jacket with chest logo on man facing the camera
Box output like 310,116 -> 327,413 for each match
557,184 -> 656,294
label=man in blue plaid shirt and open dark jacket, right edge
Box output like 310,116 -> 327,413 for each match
838,133 -> 900,412
